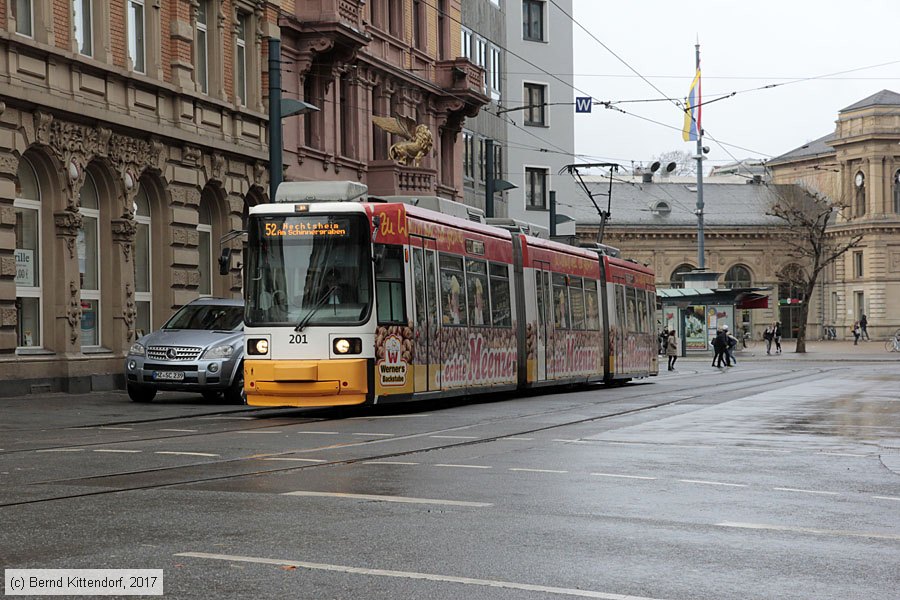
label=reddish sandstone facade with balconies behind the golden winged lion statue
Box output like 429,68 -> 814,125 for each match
278,0 -> 488,201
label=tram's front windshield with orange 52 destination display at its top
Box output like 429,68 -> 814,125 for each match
245,214 -> 372,327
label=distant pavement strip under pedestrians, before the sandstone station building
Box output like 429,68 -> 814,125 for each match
679,339 -> 900,363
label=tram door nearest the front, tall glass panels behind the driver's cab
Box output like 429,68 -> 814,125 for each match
410,236 -> 441,392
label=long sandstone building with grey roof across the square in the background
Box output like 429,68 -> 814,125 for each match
575,90 -> 900,339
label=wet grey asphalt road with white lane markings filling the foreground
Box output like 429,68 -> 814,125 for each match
0,356 -> 900,600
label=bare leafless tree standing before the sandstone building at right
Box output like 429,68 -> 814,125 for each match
766,185 -> 863,353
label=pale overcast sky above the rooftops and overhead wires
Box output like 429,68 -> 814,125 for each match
573,0 -> 900,171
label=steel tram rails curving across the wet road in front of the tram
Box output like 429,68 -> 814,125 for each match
0,368 -> 834,509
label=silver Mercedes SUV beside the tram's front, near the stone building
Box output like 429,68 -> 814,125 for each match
125,298 -> 245,404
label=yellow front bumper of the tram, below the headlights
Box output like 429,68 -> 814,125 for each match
244,359 -> 369,406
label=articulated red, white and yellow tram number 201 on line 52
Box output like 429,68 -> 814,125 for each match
244,182 -> 658,407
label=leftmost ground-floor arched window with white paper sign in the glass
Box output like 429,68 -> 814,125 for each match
13,158 -> 43,348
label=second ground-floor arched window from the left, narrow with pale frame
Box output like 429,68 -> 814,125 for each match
77,173 -> 100,347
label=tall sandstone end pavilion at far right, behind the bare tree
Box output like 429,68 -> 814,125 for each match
767,90 -> 900,338
